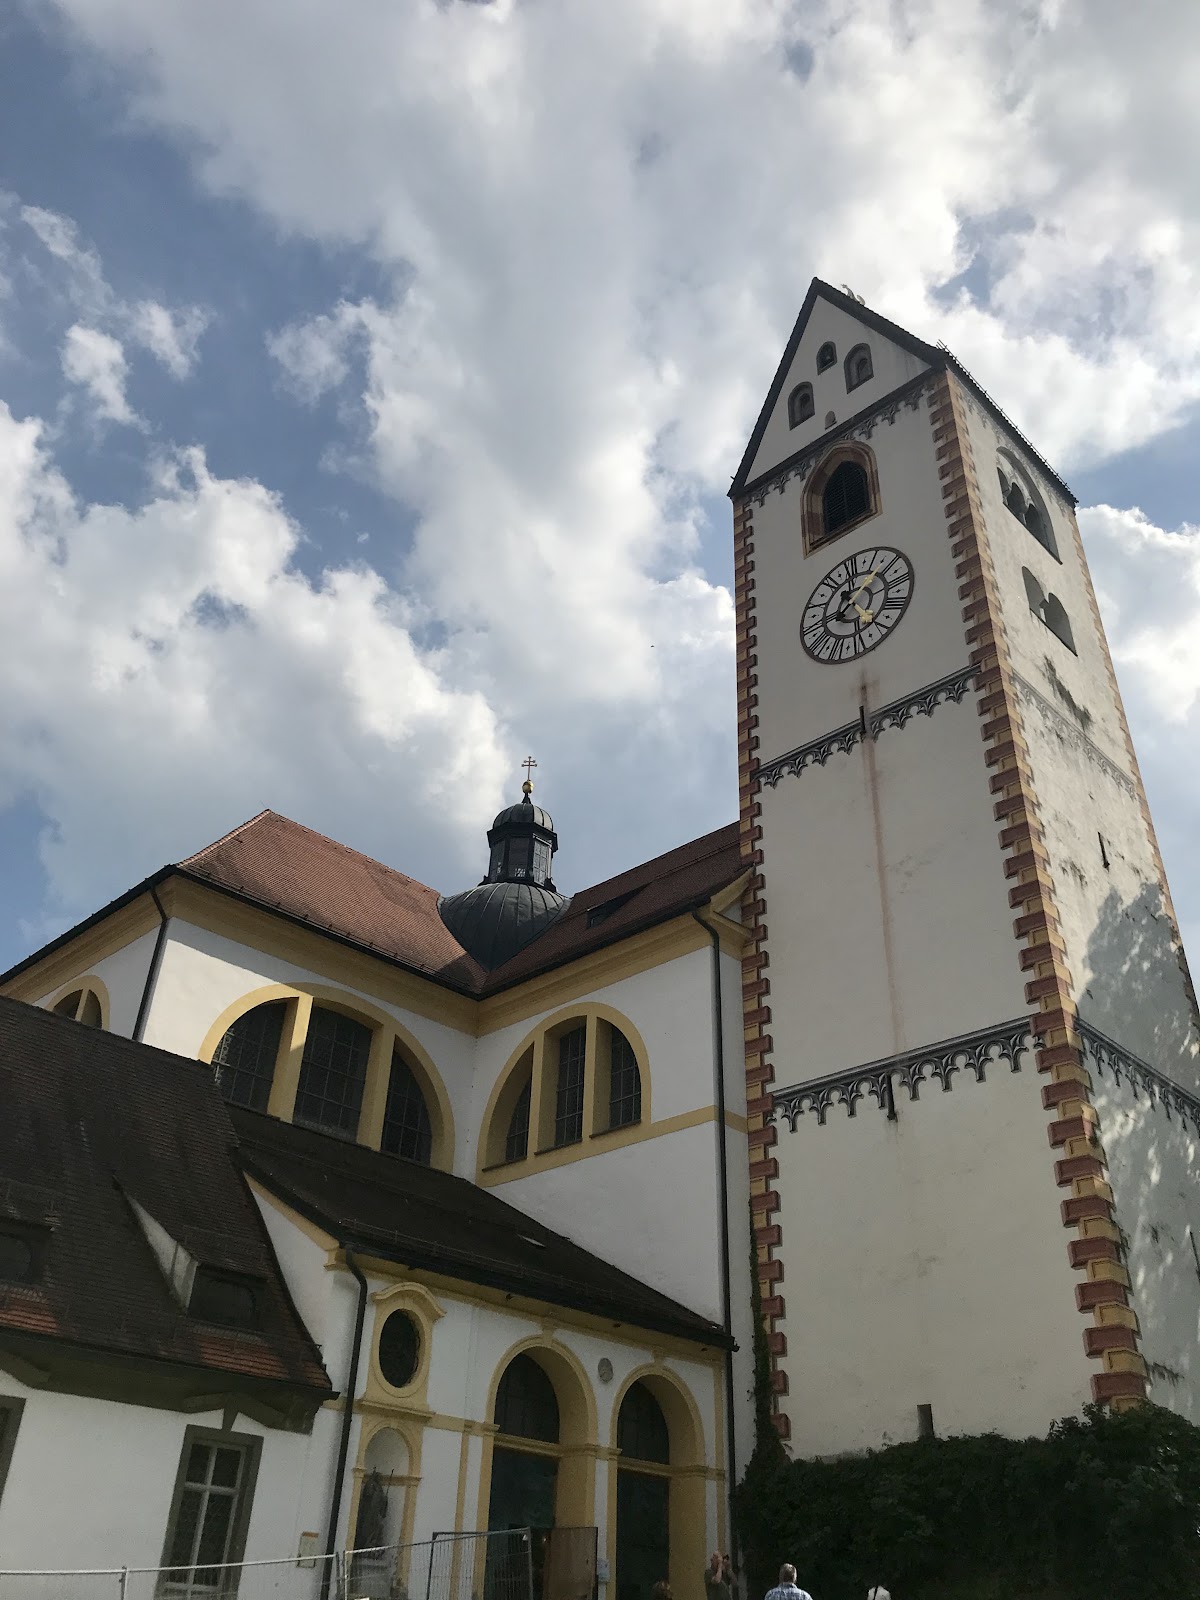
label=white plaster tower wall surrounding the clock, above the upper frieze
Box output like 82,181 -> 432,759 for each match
750,397 -> 968,760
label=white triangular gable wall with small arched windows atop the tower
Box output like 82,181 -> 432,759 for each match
750,299 -> 925,478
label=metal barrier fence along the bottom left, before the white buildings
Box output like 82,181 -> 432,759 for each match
0,1528 -> 533,1600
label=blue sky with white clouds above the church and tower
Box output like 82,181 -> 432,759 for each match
0,0 -> 1200,968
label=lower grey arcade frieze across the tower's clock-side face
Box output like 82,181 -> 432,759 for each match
770,1016 -> 1034,1133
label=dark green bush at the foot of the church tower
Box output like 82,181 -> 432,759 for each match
736,1405 -> 1200,1600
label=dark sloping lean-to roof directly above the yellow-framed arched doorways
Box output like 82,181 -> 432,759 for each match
230,1107 -> 730,1347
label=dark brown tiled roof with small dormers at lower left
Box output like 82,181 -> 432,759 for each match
0,997 -> 333,1398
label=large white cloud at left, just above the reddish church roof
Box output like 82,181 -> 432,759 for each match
0,405 -> 504,910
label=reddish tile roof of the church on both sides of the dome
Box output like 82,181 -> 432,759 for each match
178,811 -> 742,995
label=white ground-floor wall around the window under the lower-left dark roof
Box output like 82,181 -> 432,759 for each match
0,1374 -> 333,1568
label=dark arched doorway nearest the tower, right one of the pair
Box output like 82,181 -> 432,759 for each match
616,1381 -> 670,1600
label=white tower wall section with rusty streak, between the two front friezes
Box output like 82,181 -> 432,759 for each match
762,707 -> 1046,1094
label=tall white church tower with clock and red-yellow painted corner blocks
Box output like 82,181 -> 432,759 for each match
730,280 -> 1200,1454
